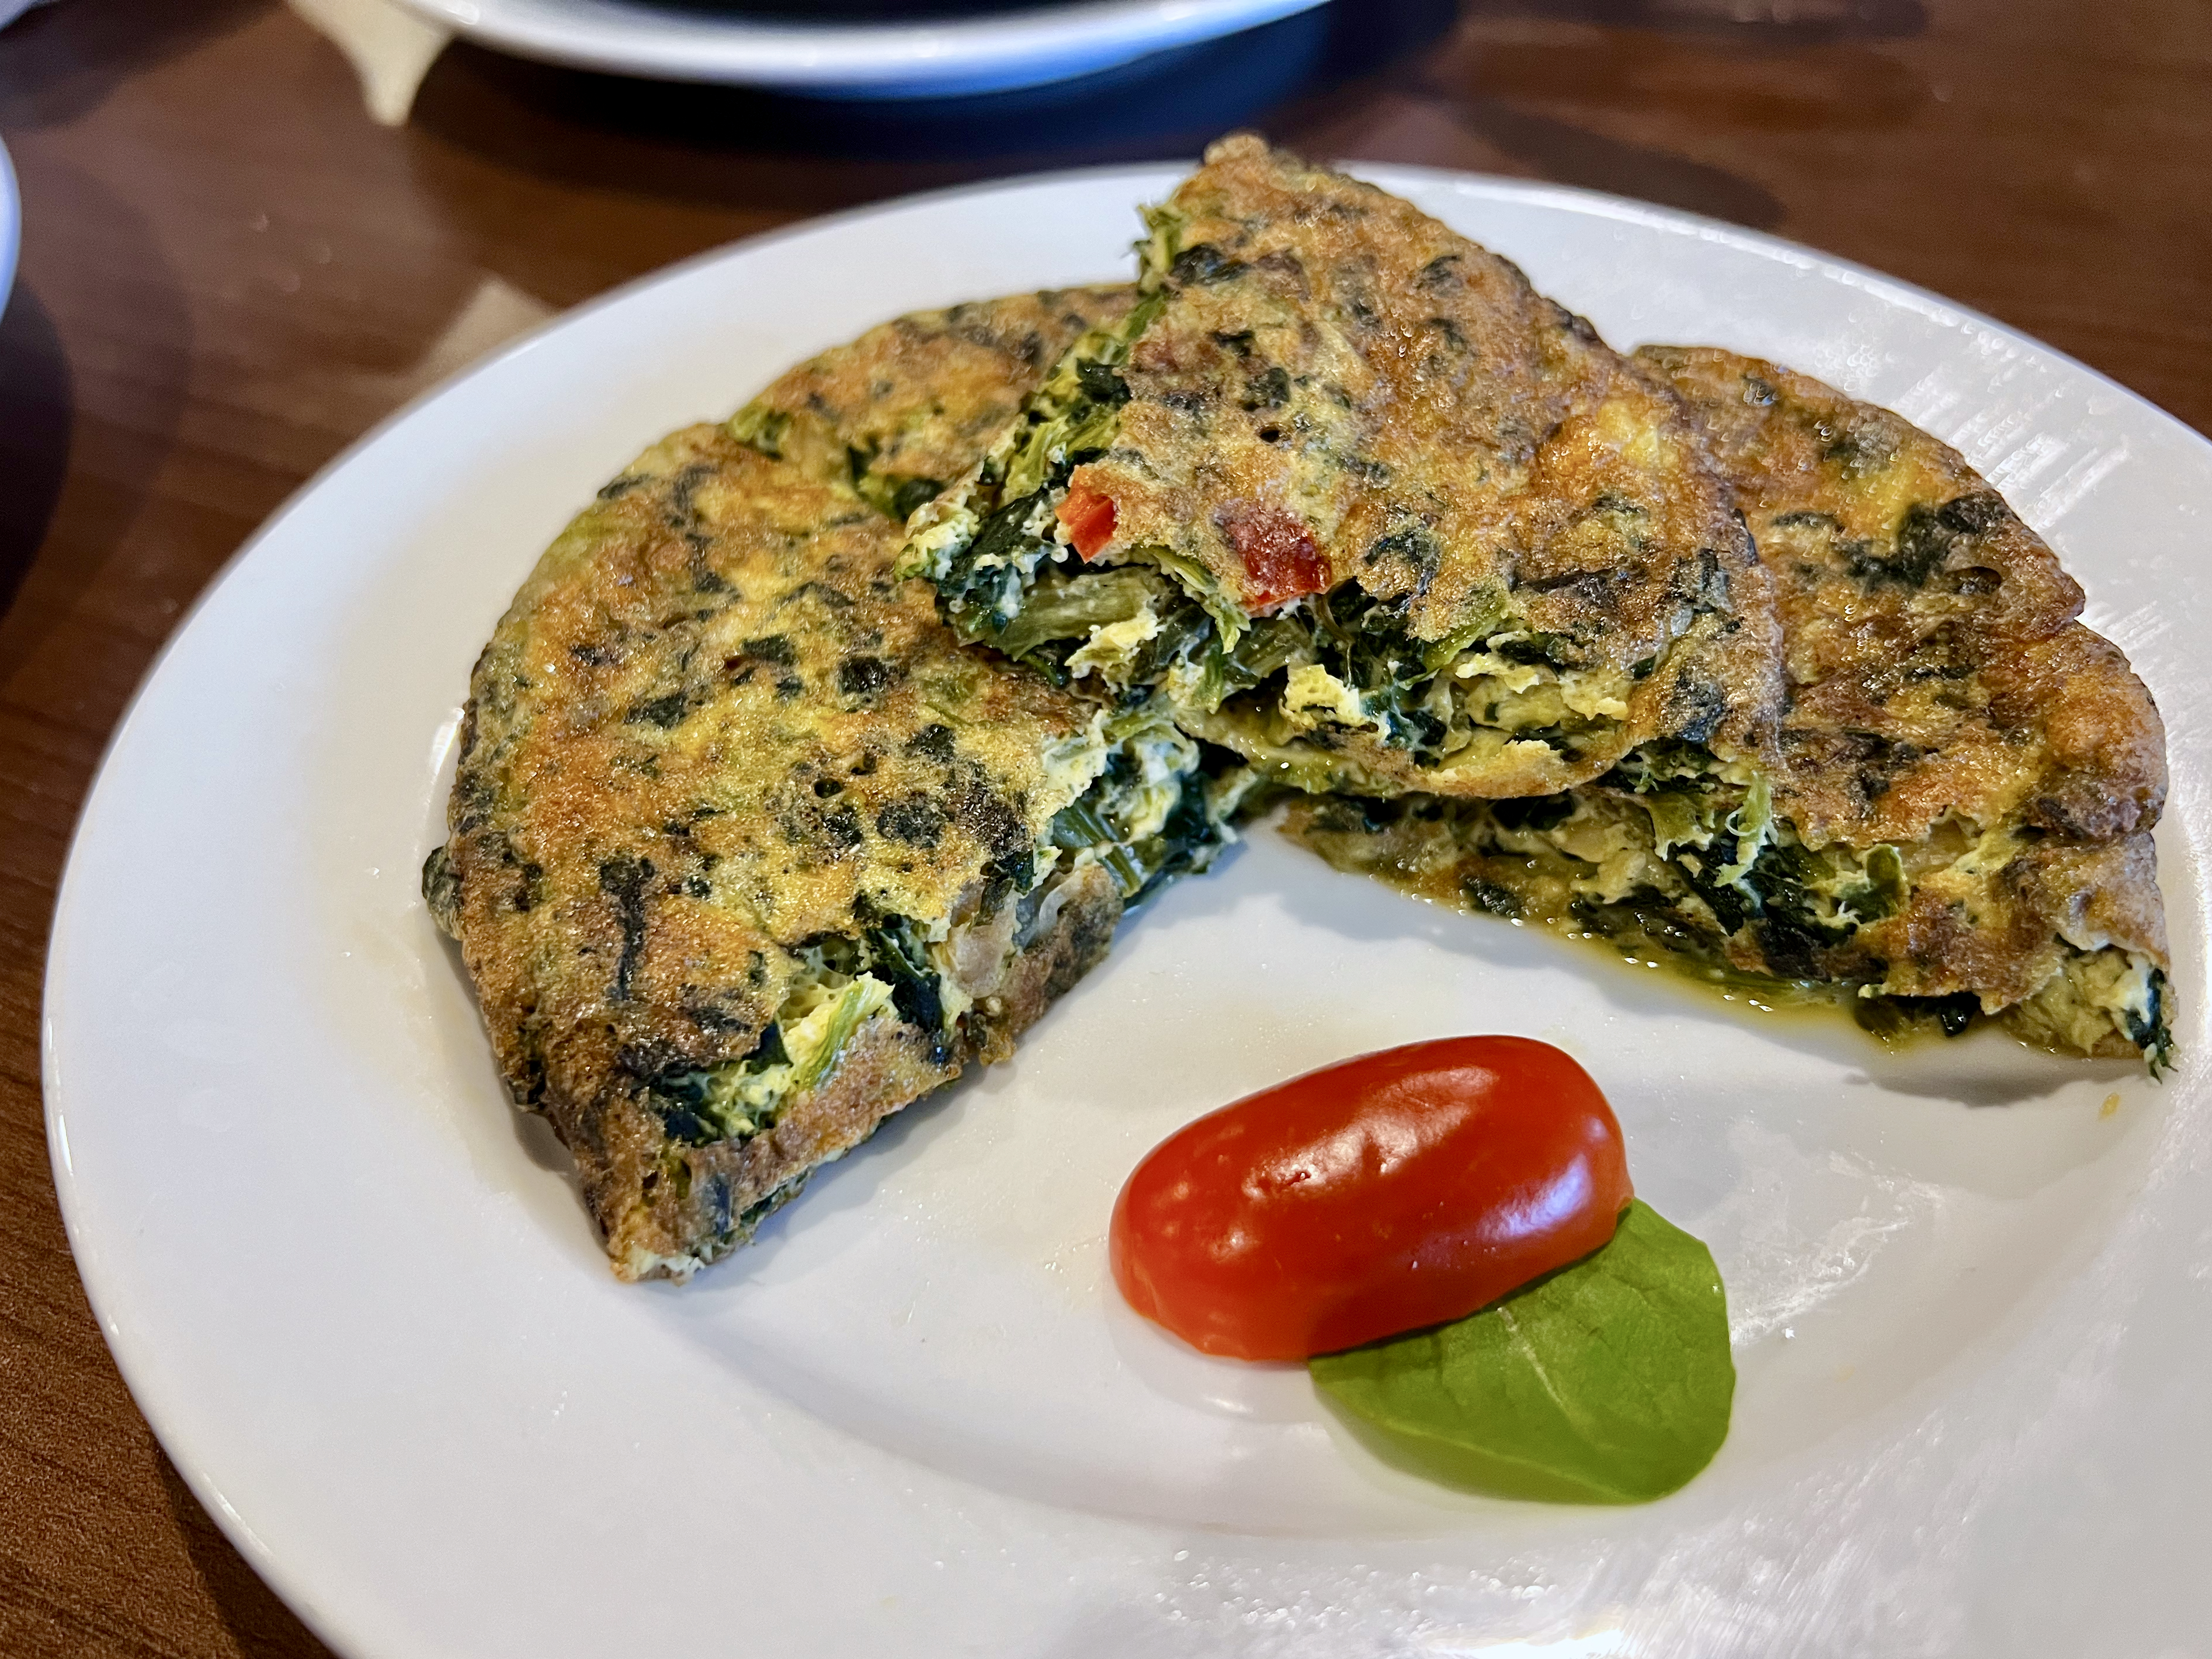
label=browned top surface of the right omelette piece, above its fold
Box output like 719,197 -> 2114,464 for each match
1637,345 -> 2165,845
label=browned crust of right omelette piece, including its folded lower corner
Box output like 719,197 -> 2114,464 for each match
1637,345 -> 2165,1004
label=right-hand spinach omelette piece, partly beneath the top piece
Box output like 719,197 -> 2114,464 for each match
1290,348 -> 2172,1071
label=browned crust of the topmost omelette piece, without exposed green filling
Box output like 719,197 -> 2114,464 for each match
1071,135 -> 1779,794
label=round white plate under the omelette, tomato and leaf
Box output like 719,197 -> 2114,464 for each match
47,168 -> 2212,1659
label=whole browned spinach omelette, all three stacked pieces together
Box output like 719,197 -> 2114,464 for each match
425,152 -> 2172,1279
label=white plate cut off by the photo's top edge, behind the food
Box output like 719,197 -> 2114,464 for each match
389,0 -> 1321,98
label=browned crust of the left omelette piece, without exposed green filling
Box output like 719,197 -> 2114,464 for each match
445,296 -> 1121,1276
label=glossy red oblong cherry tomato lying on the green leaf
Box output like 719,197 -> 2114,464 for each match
1108,1037 -> 1635,1360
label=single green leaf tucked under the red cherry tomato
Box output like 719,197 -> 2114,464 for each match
1307,1201 -> 1737,1504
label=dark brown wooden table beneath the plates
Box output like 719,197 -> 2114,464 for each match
0,0 -> 2212,1659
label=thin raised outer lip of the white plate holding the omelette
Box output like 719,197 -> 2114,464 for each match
43,159 -> 2212,1654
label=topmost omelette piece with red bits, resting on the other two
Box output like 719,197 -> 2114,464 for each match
900,135 -> 1781,796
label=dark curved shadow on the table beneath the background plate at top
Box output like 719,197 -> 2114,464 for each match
411,0 -> 1456,213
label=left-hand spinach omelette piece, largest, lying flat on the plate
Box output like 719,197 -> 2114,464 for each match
425,290 -> 1243,1279
